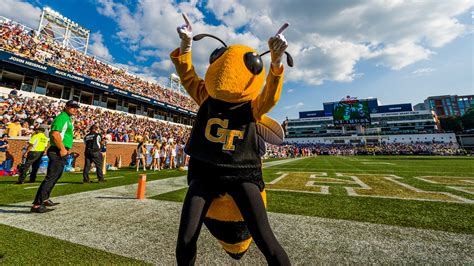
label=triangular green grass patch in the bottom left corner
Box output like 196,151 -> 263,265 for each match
0,225 -> 145,265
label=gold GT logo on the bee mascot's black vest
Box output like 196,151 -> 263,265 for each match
205,118 -> 244,151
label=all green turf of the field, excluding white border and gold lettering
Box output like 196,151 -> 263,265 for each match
0,156 -> 474,265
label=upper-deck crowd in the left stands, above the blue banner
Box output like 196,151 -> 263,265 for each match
0,18 -> 198,111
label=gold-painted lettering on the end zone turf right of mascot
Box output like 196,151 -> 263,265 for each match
267,172 -> 474,203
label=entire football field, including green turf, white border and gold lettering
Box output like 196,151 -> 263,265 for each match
0,156 -> 474,264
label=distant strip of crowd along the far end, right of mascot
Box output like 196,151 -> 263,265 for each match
265,142 -> 467,158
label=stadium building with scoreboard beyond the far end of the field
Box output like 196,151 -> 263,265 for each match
284,97 -> 456,144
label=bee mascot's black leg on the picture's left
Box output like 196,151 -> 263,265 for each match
176,179 -> 212,265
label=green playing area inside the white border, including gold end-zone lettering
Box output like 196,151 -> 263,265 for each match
157,156 -> 474,234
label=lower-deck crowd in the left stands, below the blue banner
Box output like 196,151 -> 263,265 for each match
0,93 -> 190,143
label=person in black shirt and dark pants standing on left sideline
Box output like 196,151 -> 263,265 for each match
82,125 -> 105,183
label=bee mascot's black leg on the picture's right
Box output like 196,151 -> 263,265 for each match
229,182 -> 290,265
